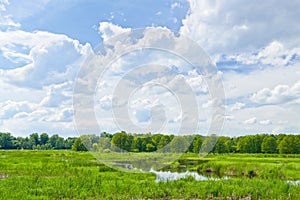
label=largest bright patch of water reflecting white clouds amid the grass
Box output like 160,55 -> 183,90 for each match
150,169 -> 228,182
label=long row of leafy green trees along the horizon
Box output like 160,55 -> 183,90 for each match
0,131 -> 300,154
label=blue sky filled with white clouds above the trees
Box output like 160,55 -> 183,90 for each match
0,0 -> 300,137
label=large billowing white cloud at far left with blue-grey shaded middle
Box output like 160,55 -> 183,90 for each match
0,31 -> 91,88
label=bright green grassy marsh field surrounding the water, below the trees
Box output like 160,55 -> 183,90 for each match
0,150 -> 300,199
